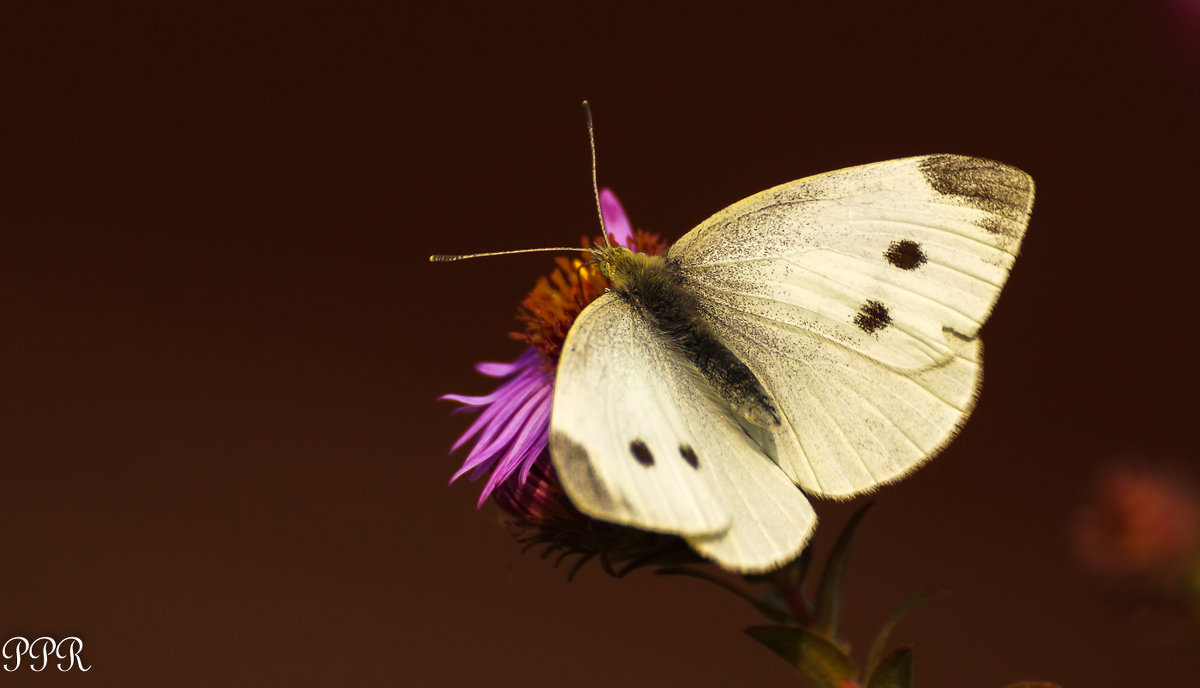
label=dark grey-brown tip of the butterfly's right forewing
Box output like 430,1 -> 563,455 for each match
920,155 -> 1033,234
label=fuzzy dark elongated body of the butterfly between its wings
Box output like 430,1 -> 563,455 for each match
592,246 -> 779,427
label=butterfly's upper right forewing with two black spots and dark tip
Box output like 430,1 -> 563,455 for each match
668,156 -> 1033,369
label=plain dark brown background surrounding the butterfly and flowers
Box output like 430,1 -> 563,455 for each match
0,0 -> 1200,687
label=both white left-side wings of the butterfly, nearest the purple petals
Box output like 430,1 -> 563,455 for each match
551,289 -> 815,570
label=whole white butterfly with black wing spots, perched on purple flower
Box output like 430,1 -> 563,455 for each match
550,155 -> 1033,573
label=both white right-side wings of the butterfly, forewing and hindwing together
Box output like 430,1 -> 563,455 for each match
668,156 -> 1033,496
